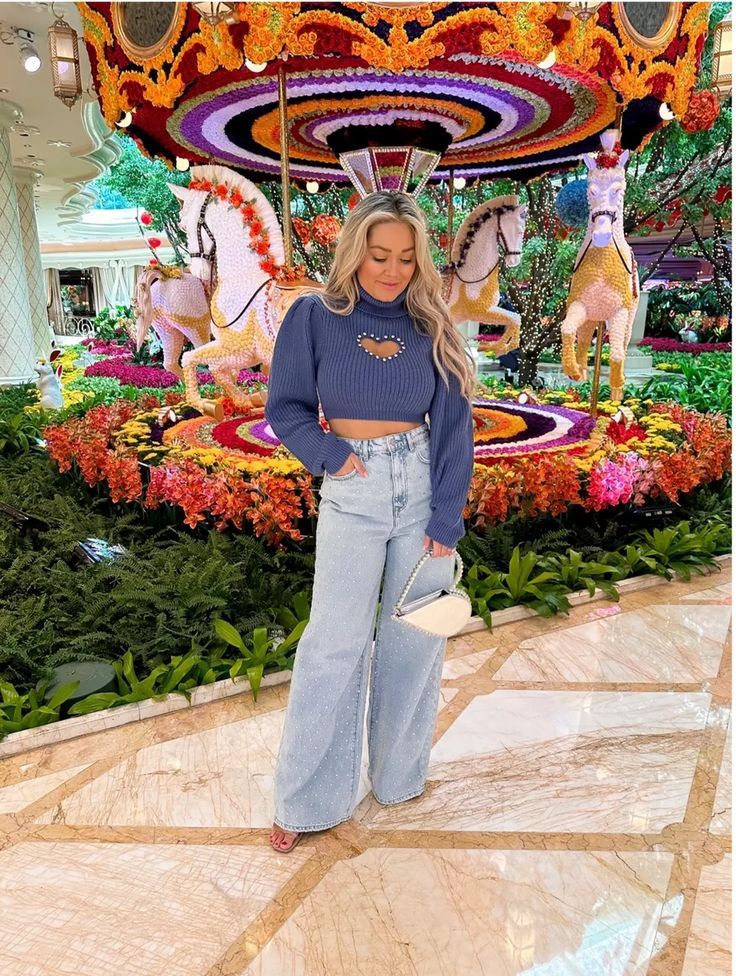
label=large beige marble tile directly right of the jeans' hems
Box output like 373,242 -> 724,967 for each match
361,690 -> 710,833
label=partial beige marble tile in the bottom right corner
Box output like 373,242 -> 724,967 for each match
682,855 -> 731,976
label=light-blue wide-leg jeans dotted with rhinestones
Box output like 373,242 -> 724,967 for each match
274,425 -> 454,831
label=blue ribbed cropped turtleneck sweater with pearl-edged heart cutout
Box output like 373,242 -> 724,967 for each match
266,288 -> 473,548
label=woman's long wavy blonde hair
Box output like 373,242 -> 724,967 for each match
318,190 -> 475,399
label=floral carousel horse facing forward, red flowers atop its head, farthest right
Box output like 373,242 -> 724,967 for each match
562,129 -> 639,400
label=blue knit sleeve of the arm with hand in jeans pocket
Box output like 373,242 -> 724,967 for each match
266,295 -> 352,474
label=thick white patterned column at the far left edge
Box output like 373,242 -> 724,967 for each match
0,99 -> 36,386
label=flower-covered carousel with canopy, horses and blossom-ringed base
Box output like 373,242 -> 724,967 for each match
41,2 -> 727,545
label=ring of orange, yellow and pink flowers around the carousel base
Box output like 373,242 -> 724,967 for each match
44,390 -> 731,547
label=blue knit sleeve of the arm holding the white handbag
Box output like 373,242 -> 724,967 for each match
426,373 -> 473,549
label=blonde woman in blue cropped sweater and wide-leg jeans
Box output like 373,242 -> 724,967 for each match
266,191 -> 474,853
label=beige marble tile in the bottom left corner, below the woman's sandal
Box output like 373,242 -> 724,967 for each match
0,843 -> 313,976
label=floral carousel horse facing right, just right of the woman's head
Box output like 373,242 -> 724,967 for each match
446,195 -> 527,355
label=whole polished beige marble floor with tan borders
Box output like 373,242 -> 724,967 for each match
0,566 -> 731,976
